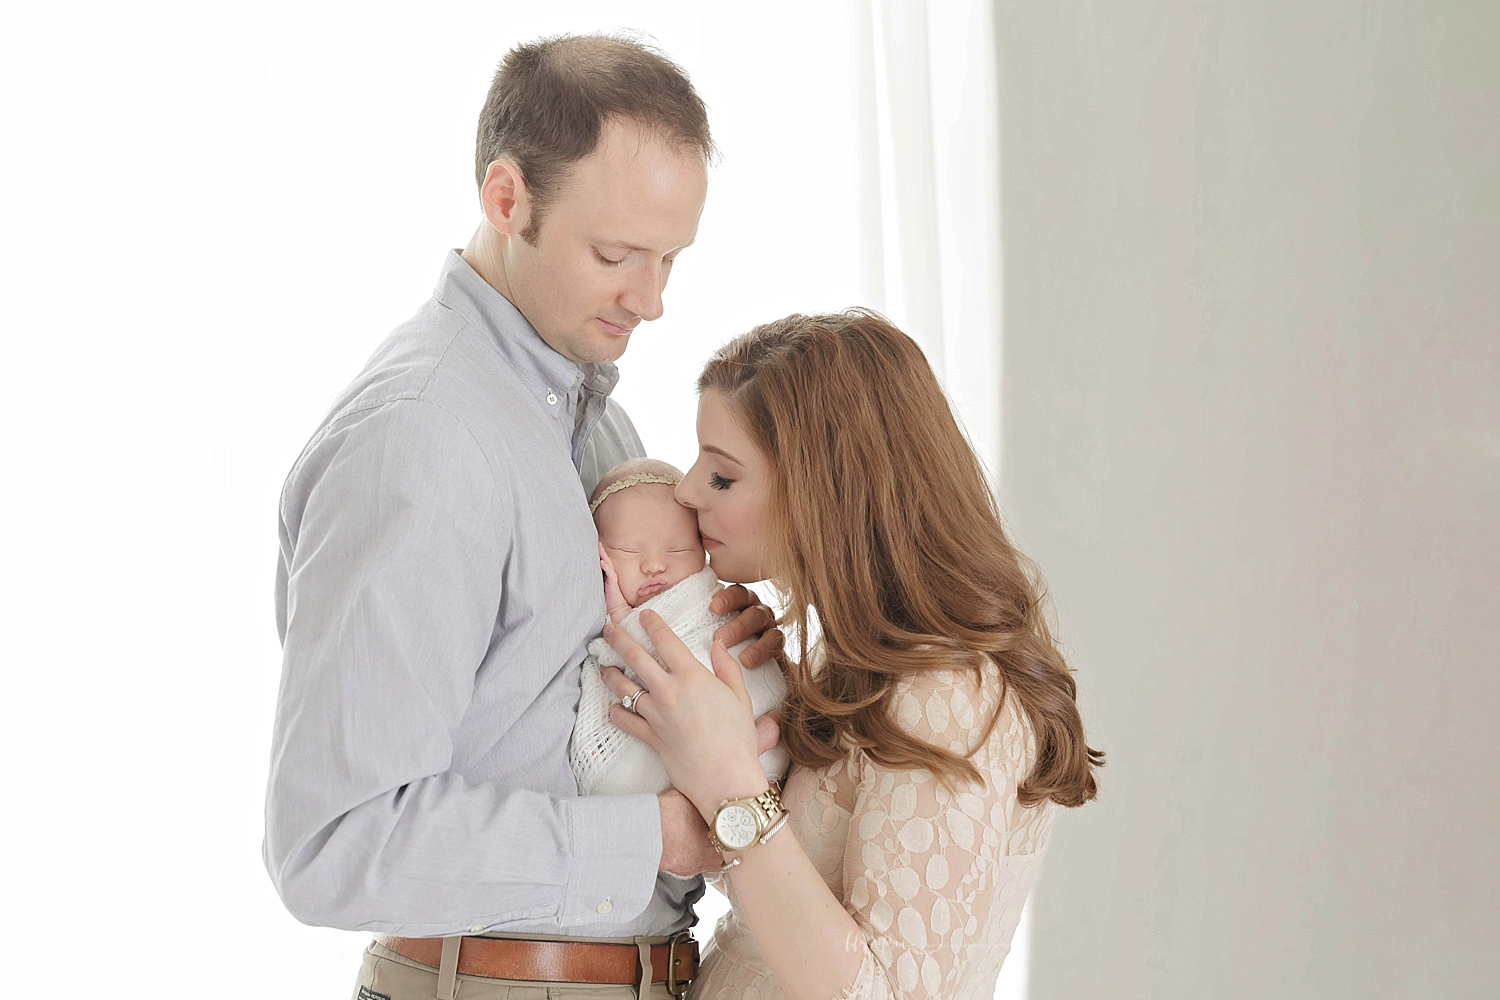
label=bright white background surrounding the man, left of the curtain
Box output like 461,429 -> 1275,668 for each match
0,0 -> 860,997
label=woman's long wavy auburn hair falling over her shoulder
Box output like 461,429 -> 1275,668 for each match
698,309 -> 1104,805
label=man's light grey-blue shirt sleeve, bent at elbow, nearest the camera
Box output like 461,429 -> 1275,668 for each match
264,399 -> 662,936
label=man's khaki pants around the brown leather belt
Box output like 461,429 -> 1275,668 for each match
353,937 -> 677,1000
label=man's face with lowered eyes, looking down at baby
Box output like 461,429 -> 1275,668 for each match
506,121 -> 708,361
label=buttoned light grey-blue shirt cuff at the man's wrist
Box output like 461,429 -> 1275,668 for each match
560,795 -> 662,927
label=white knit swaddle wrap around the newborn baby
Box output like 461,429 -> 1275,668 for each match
570,567 -> 789,795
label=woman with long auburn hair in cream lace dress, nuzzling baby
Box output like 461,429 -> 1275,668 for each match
606,310 -> 1103,1000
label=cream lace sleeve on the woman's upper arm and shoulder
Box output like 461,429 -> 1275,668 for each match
836,673 -> 1052,1000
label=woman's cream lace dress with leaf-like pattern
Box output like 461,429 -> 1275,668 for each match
689,673 -> 1053,1000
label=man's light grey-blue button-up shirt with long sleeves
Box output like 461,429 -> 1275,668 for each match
264,252 -> 702,937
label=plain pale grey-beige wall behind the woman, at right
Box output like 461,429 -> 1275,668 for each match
998,0 -> 1500,1000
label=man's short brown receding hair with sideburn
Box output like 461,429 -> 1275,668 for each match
474,34 -> 714,246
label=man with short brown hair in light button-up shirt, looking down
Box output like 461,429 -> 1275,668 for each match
264,36 -> 780,999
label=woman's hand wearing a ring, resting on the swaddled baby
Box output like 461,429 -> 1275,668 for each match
603,612 -> 768,820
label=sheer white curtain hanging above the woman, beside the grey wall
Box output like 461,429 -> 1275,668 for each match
851,0 -> 1001,480
